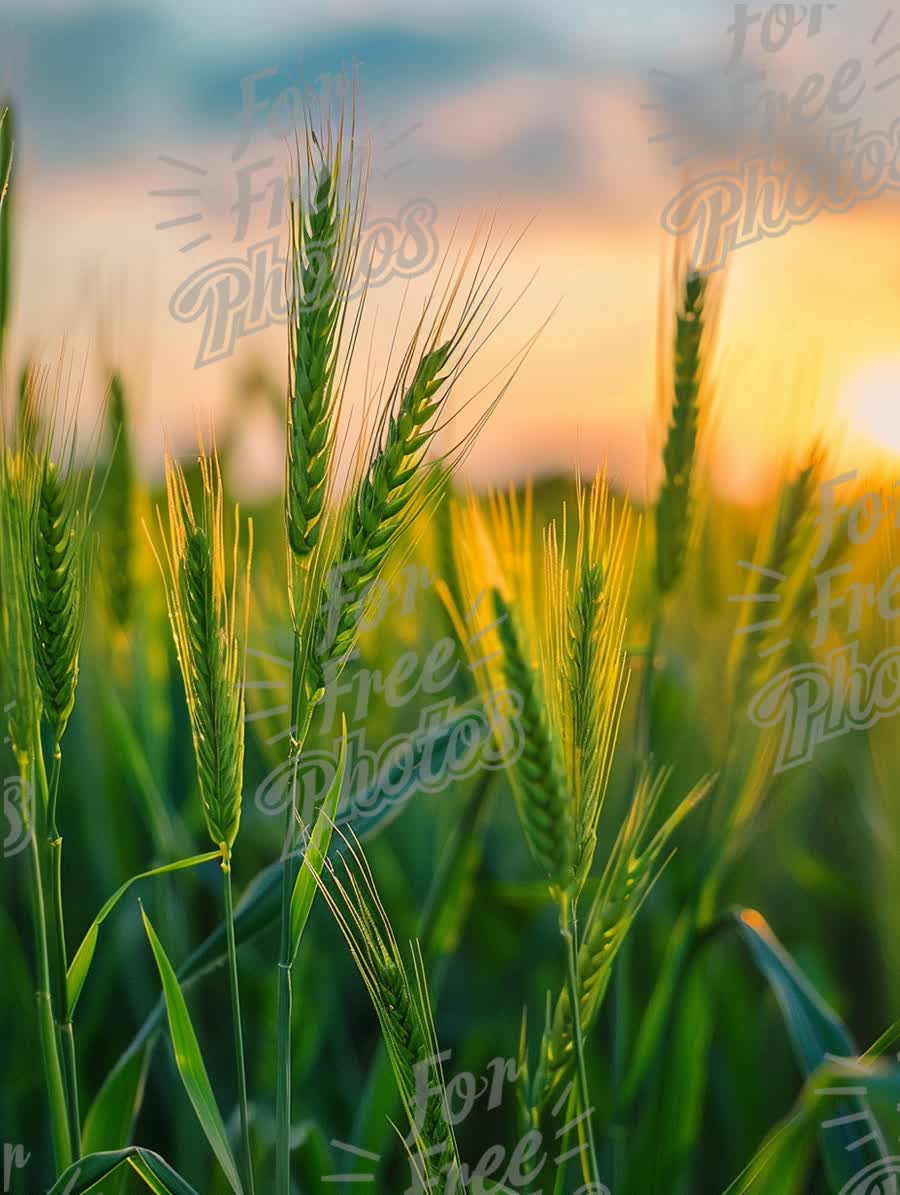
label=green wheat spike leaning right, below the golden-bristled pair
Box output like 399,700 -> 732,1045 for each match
533,770 -> 711,1115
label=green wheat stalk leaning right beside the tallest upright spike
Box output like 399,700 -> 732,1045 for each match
276,230 -> 512,1195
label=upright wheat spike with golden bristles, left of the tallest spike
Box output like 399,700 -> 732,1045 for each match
151,447 -> 252,864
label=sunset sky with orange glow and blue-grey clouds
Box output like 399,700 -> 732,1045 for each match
0,0 -> 900,496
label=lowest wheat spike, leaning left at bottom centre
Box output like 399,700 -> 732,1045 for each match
312,831 -> 464,1190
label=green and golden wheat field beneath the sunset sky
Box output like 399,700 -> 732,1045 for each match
0,100 -> 900,1195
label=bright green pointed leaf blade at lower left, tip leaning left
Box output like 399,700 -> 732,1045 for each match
141,908 -> 244,1195
